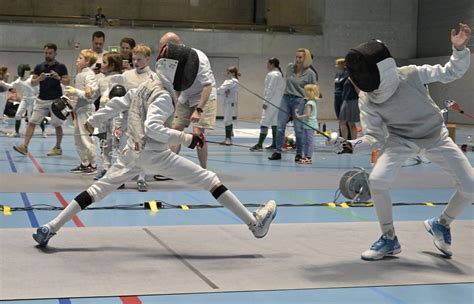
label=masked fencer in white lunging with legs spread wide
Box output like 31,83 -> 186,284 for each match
33,44 -> 277,246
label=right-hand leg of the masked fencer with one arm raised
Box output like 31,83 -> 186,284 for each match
424,137 -> 474,256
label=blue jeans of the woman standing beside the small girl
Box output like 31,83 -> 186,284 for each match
276,95 -> 304,155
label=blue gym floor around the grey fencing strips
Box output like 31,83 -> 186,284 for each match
0,121 -> 474,304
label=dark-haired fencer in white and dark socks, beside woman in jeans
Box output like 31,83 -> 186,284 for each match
250,57 -> 286,151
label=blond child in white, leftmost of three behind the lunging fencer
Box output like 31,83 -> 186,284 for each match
64,49 -> 99,175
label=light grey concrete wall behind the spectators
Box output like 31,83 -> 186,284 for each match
0,0 -> 472,125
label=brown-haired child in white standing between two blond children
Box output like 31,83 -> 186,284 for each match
94,52 -> 125,180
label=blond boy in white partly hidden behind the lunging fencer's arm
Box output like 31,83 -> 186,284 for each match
119,43 -> 155,192
